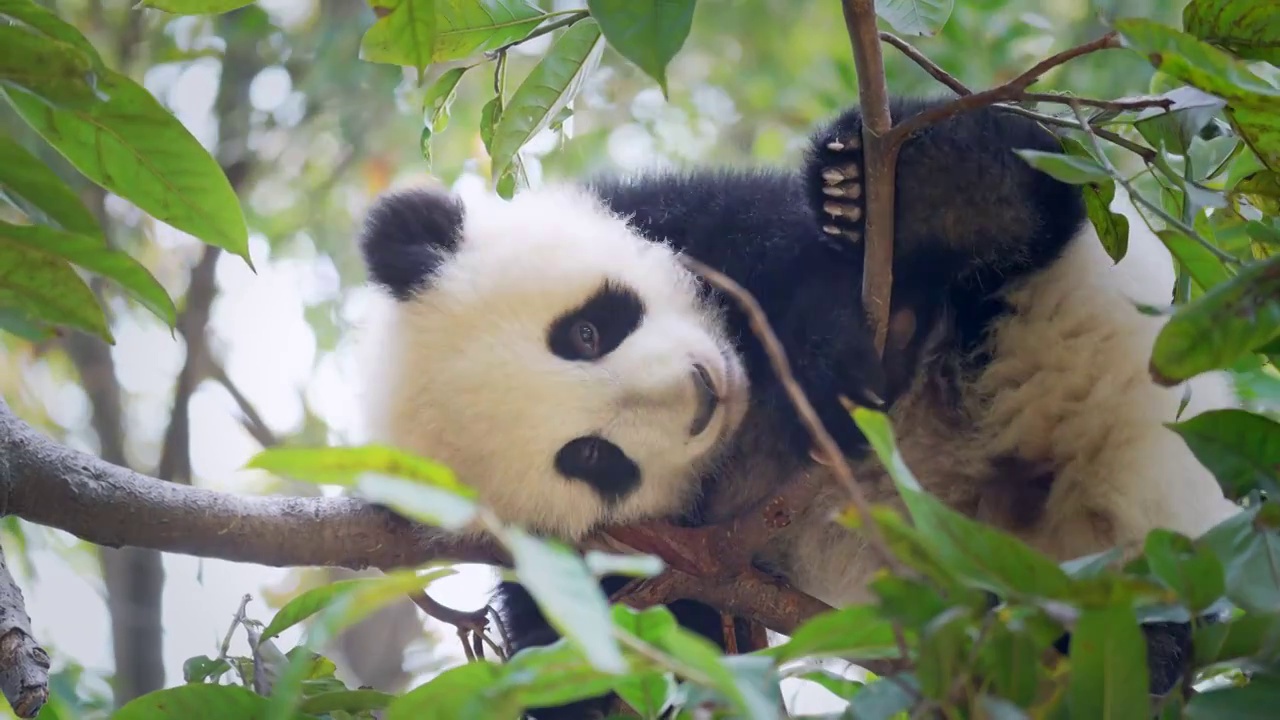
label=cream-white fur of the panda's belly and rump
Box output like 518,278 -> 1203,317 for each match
777,204 -> 1239,606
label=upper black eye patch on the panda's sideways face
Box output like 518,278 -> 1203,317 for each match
547,281 -> 645,360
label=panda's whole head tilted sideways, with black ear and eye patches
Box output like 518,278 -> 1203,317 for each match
361,187 -> 748,538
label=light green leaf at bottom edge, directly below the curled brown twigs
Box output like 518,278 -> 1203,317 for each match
384,660 -> 509,720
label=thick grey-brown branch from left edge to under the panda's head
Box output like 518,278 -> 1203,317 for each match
0,401 -> 506,570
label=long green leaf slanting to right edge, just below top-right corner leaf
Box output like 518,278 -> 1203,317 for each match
1115,18 -> 1280,110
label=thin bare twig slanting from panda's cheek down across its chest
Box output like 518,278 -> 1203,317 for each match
681,255 -> 906,574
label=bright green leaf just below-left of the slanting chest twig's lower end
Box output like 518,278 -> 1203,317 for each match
763,605 -> 899,662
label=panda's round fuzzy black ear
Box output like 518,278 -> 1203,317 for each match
360,188 -> 465,301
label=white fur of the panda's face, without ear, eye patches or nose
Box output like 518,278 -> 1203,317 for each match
358,187 -> 748,538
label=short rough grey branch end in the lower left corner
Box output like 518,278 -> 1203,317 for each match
0,540 -> 49,717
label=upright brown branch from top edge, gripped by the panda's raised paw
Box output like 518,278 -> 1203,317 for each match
841,0 -> 900,354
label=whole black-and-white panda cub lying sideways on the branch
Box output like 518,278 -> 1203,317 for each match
362,100 -> 1236,719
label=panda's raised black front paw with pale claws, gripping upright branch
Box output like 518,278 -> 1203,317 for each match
805,110 -> 865,250
